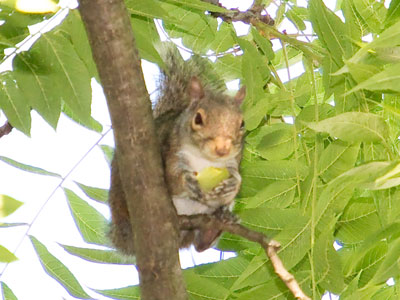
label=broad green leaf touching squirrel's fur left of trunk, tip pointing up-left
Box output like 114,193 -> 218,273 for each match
64,188 -> 109,246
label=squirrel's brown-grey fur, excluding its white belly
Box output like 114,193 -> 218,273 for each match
109,48 -> 245,255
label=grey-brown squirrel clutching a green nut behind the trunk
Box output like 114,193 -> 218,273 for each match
109,47 -> 246,255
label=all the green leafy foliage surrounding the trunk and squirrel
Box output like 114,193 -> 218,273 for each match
0,0 -> 400,300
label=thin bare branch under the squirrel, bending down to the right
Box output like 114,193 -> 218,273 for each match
179,215 -> 311,300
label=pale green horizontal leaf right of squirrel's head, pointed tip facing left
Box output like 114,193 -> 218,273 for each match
308,112 -> 389,143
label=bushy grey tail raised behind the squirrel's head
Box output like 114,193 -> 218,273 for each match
154,43 -> 225,117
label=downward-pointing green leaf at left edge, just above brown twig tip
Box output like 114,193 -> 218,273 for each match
0,71 -> 31,136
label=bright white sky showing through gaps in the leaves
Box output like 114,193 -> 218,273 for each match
0,0 -> 335,300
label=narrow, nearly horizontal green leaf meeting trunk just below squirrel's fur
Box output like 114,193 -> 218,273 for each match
60,245 -> 136,265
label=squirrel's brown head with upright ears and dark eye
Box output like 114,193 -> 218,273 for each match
188,77 -> 246,160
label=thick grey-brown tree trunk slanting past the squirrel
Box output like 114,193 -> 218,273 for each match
79,0 -> 187,300
